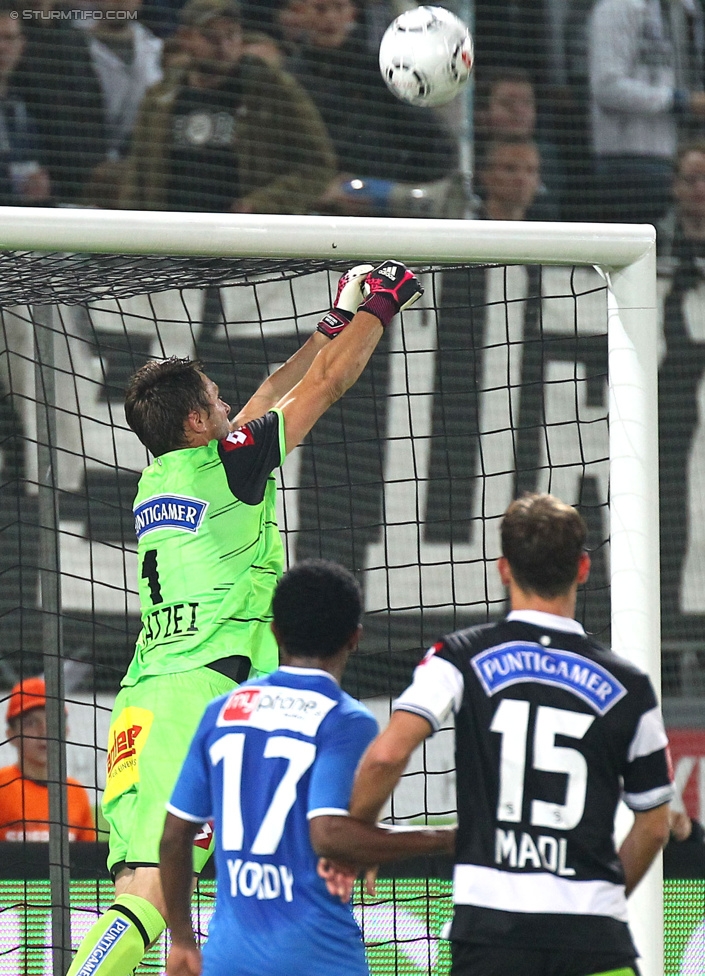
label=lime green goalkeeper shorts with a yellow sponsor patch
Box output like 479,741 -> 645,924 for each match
103,668 -> 236,873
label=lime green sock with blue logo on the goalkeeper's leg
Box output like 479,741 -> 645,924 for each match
66,895 -> 166,976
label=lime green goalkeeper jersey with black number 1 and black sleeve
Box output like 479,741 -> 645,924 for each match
122,410 -> 285,685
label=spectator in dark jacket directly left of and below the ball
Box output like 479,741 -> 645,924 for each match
282,0 -> 455,215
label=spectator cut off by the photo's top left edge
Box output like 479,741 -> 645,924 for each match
0,0 -> 51,206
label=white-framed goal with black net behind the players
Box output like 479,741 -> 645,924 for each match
0,211 -> 660,976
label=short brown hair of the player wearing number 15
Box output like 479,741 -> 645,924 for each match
501,494 -> 587,599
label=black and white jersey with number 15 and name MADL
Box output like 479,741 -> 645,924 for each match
394,611 -> 673,953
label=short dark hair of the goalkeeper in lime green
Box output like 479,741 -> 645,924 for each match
125,356 -> 210,457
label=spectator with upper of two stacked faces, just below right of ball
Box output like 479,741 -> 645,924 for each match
477,68 -> 565,219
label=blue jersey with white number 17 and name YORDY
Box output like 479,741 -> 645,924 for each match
167,668 -> 377,976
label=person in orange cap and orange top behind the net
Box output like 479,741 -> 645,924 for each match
0,678 -> 95,841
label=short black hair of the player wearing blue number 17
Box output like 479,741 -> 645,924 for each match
272,559 -> 362,658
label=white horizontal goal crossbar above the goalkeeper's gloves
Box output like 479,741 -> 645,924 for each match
0,207 -> 655,268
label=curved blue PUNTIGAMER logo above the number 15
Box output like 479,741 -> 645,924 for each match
472,641 -> 627,715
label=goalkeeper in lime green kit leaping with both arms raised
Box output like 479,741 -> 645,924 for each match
69,261 -> 423,976
